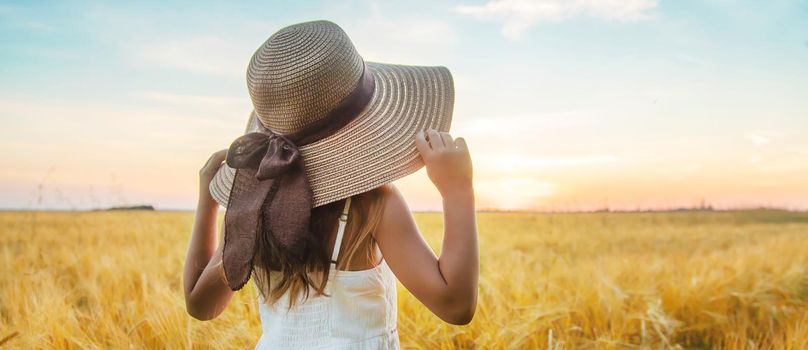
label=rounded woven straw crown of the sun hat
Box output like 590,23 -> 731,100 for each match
247,21 -> 364,134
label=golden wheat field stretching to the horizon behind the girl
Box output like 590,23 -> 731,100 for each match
0,211 -> 808,349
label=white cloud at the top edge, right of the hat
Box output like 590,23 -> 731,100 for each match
455,0 -> 657,40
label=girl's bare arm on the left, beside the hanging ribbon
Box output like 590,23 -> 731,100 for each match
183,150 -> 233,320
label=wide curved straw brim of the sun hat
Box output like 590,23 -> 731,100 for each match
210,62 -> 454,207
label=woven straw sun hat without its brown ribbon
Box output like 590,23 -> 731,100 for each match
210,21 -> 454,207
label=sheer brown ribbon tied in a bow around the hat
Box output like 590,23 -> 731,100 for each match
222,66 -> 375,290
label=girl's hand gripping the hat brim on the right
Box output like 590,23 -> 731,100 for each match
415,129 -> 473,197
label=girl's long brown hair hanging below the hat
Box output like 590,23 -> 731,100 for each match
253,186 -> 387,307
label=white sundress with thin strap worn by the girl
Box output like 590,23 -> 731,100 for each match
255,197 -> 399,350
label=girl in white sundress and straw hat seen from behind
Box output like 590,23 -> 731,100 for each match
184,21 -> 479,349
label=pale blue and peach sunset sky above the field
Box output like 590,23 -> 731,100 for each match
0,0 -> 808,211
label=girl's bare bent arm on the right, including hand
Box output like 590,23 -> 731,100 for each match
376,131 -> 479,324
